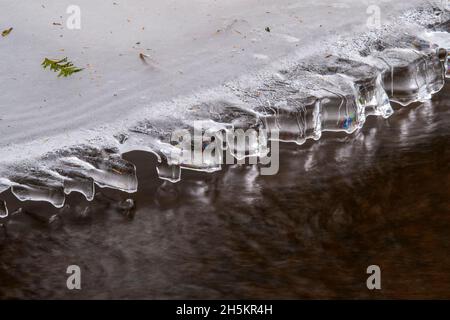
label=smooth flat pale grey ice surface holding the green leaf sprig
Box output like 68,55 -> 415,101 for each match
0,0 -> 432,161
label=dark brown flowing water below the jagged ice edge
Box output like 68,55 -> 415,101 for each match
0,85 -> 450,299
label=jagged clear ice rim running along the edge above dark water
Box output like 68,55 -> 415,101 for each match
0,2 -> 450,214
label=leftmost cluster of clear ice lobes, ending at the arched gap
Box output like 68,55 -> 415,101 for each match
0,146 -> 137,208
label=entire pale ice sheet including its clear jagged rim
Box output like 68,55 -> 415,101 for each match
0,0 -> 449,211
